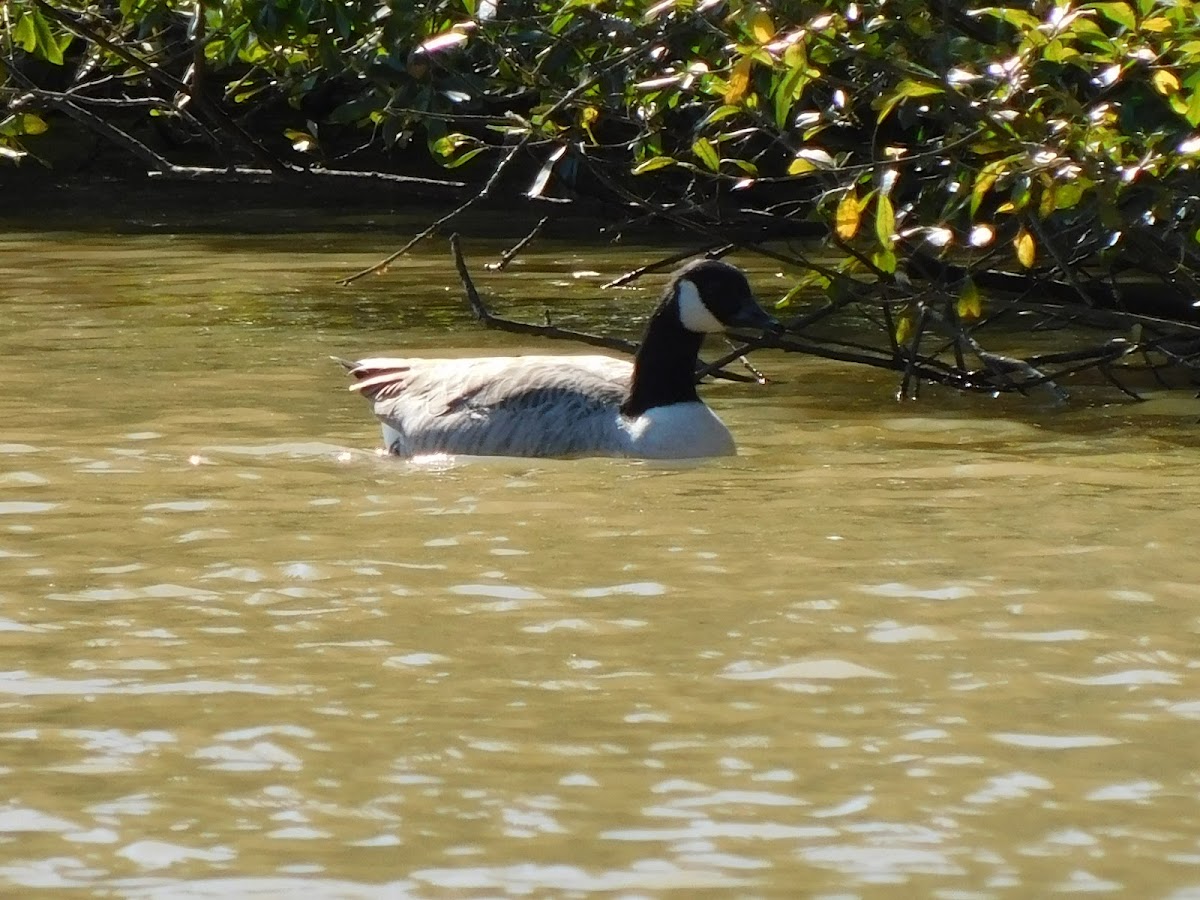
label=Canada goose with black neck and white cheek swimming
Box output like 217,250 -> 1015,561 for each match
335,259 -> 778,460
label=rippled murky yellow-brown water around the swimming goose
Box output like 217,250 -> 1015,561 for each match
0,224 -> 1200,898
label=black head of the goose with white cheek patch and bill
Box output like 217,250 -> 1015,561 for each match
667,259 -> 779,335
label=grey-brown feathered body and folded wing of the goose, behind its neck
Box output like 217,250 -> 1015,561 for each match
350,356 -> 632,456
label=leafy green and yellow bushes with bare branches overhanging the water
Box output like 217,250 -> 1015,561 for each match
7,0 -> 1200,400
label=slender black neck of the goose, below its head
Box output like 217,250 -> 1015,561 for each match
620,300 -> 704,415
